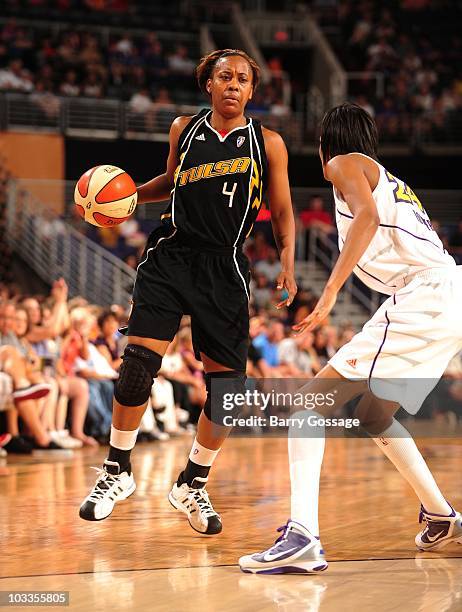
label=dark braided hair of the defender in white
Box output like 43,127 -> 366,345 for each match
321,102 -> 378,163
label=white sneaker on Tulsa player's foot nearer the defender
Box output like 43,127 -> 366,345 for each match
168,477 -> 223,535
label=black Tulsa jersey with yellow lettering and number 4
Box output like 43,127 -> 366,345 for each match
167,109 -> 268,246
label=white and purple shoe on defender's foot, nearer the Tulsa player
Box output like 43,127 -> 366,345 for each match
239,519 -> 327,574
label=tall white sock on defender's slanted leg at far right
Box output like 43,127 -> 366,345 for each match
372,419 -> 451,516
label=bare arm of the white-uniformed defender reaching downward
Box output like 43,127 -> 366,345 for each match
293,155 -> 380,333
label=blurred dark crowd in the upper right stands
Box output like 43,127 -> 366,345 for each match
313,0 -> 462,142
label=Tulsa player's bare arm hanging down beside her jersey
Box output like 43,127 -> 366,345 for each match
263,130 -> 297,308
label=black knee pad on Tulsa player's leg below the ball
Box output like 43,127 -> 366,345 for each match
114,344 -> 162,406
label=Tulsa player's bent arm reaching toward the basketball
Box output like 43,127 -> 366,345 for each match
138,117 -> 191,204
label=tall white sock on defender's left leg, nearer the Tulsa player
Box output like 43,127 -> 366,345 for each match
289,411 -> 326,536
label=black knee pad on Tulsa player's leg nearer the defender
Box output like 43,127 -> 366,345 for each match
204,370 -> 247,425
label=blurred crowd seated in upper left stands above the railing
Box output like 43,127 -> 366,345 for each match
0,20 -> 199,106
